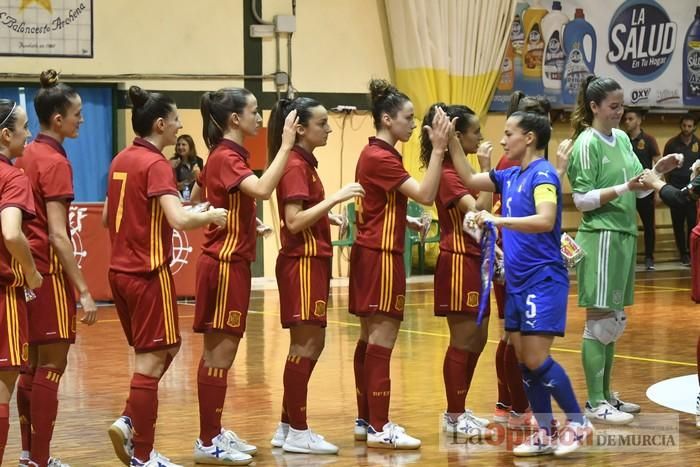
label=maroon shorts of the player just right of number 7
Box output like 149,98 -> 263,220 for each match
192,254 -> 251,337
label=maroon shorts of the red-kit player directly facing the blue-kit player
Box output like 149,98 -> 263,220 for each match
433,251 -> 491,316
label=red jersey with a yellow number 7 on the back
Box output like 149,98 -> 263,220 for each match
107,138 -> 179,274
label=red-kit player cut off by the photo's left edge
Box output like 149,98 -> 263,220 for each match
0,99 -> 42,464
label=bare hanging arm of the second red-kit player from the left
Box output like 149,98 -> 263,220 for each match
46,201 -> 97,324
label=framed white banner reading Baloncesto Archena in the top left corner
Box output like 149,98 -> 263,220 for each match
0,0 -> 93,58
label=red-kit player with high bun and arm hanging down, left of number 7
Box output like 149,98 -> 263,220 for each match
17,70 -> 97,467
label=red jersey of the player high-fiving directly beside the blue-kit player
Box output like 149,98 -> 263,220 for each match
435,160 -> 481,256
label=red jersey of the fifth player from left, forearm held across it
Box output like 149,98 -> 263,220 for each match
277,146 -> 333,258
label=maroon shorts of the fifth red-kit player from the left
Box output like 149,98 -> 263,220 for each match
275,255 -> 331,328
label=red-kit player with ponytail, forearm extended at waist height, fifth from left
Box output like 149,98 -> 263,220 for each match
268,97 -> 364,454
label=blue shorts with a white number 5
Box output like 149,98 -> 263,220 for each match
505,277 -> 569,336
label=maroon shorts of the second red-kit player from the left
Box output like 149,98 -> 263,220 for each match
27,272 -> 77,345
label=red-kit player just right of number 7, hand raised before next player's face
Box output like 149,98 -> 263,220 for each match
193,88 -> 297,465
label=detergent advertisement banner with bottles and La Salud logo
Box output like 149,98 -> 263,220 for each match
489,0 -> 700,112
